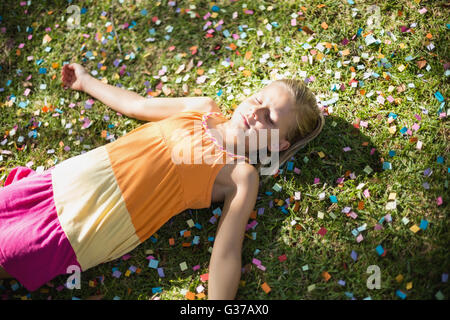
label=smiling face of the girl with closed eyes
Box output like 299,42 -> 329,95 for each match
230,83 -> 296,152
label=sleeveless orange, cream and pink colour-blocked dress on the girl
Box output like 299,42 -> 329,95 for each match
0,111 -> 235,291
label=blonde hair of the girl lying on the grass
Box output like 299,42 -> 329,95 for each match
255,79 -> 325,181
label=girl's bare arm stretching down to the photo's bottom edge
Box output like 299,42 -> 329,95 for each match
208,164 -> 259,300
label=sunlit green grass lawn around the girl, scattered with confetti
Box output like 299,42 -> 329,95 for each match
0,0 -> 450,300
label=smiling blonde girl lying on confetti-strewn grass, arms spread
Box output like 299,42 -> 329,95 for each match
0,63 -> 324,299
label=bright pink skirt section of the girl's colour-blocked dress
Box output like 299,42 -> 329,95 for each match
0,167 -> 81,291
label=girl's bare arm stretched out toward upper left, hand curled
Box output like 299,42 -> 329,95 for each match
61,63 -> 220,121
